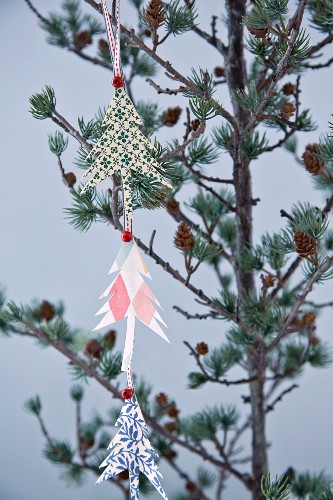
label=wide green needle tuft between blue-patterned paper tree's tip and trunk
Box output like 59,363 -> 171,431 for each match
180,405 -> 239,444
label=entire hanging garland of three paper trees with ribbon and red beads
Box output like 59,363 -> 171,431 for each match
82,0 -> 172,500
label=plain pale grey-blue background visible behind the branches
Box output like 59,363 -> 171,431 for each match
0,0 -> 333,500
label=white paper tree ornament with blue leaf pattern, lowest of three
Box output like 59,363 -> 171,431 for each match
97,395 -> 168,500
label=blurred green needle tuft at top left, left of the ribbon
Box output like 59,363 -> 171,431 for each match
40,0 -> 105,50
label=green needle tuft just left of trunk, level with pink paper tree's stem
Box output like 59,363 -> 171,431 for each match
202,344 -> 242,379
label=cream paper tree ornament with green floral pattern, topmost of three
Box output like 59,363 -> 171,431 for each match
82,88 -> 172,221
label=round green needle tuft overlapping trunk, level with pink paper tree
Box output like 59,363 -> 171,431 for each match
241,293 -> 284,336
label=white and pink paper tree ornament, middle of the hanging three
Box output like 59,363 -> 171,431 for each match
94,239 -> 169,371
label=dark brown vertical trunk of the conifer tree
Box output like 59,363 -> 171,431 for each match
226,0 -> 267,500
